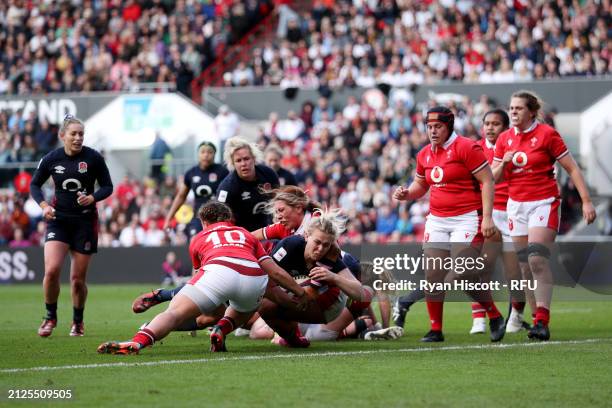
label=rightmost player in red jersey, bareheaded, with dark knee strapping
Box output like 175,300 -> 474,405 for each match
493,91 -> 596,340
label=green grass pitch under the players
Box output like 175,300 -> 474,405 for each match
0,285 -> 612,408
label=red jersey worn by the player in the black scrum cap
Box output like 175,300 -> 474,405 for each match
416,132 -> 489,217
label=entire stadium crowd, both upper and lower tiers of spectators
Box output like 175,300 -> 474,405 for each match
0,0 -> 612,247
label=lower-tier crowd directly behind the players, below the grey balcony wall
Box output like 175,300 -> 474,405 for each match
0,90 -> 580,247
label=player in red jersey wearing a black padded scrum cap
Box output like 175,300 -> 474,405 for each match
393,106 -> 505,342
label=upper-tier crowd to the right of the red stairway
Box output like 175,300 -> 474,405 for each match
225,0 -> 612,88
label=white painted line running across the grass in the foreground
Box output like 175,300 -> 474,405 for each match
0,338 -> 612,374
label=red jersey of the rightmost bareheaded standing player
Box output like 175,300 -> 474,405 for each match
494,122 -> 569,202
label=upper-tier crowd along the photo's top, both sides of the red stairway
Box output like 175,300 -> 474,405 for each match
0,0 -> 612,95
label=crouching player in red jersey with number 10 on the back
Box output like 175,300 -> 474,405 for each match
98,202 -> 308,354
